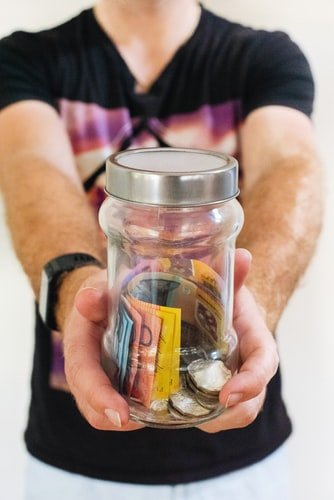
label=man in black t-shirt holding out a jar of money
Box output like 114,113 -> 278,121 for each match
0,0 -> 321,500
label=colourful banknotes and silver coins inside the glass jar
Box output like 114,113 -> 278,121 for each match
108,259 -> 236,417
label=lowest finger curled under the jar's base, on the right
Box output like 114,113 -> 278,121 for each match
198,390 -> 266,433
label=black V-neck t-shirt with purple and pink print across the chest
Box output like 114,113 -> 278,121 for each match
0,9 -> 314,484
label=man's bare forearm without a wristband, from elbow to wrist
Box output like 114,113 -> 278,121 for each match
238,151 -> 323,331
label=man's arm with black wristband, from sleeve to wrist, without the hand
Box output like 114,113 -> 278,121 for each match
0,101 -> 105,325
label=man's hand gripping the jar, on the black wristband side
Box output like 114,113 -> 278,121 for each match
64,271 -> 142,431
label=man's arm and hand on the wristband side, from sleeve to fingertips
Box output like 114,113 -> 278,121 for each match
0,101 -> 138,430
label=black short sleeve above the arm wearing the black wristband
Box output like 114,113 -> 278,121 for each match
0,32 -> 54,109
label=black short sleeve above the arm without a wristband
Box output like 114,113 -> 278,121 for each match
243,31 -> 314,116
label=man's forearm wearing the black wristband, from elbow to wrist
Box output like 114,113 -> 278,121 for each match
1,155 -> 104,324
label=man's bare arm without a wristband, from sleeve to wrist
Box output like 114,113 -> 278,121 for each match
238,106 -> 324,331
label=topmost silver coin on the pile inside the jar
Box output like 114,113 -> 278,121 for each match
188,359 -> 232,396
